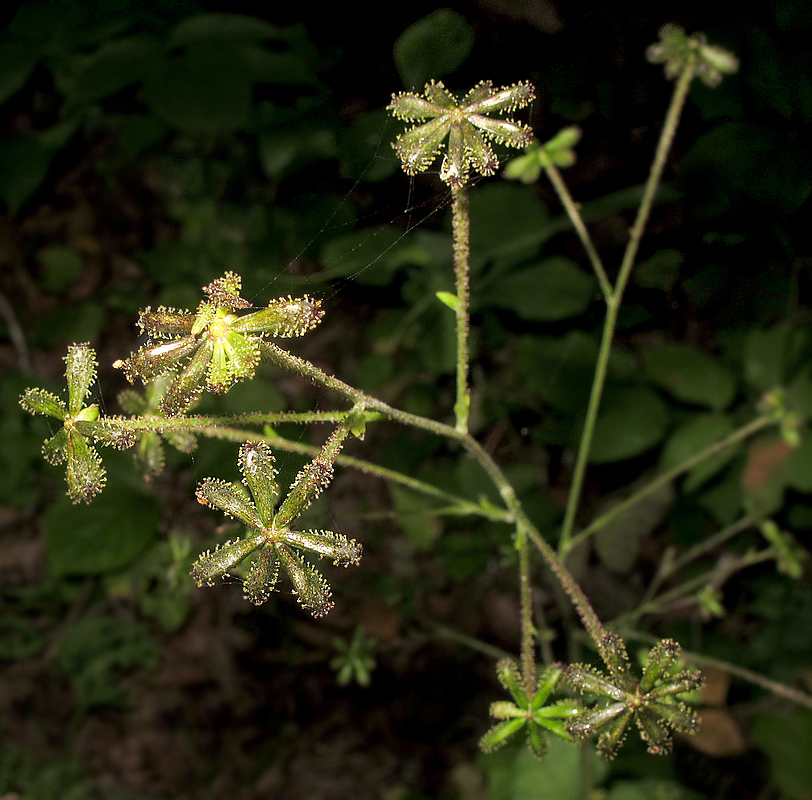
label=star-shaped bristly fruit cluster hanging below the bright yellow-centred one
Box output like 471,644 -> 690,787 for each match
192,434 -> 362,617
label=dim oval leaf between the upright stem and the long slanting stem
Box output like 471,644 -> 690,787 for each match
484,256 -> 595,322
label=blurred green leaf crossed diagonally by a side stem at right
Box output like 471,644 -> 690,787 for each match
660,414 -> 741,492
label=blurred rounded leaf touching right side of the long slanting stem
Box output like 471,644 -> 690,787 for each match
589,388 -> 669,464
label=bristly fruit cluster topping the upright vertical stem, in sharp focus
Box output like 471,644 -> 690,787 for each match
388,81 -> 535,187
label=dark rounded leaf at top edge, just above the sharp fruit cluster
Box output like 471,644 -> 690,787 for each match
393,8 -> 474,89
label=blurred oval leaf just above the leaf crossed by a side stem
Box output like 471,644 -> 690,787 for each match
643,343 -> 736,411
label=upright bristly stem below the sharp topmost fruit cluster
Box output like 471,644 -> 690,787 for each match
451,185 -> 471,433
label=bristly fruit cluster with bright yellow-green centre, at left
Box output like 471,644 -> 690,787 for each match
113,272 -> 324,417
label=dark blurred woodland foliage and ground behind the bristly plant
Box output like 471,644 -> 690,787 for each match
0,0 -> 812,800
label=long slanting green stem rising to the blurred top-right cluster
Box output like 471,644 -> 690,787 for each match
559,59 -> 695,554
